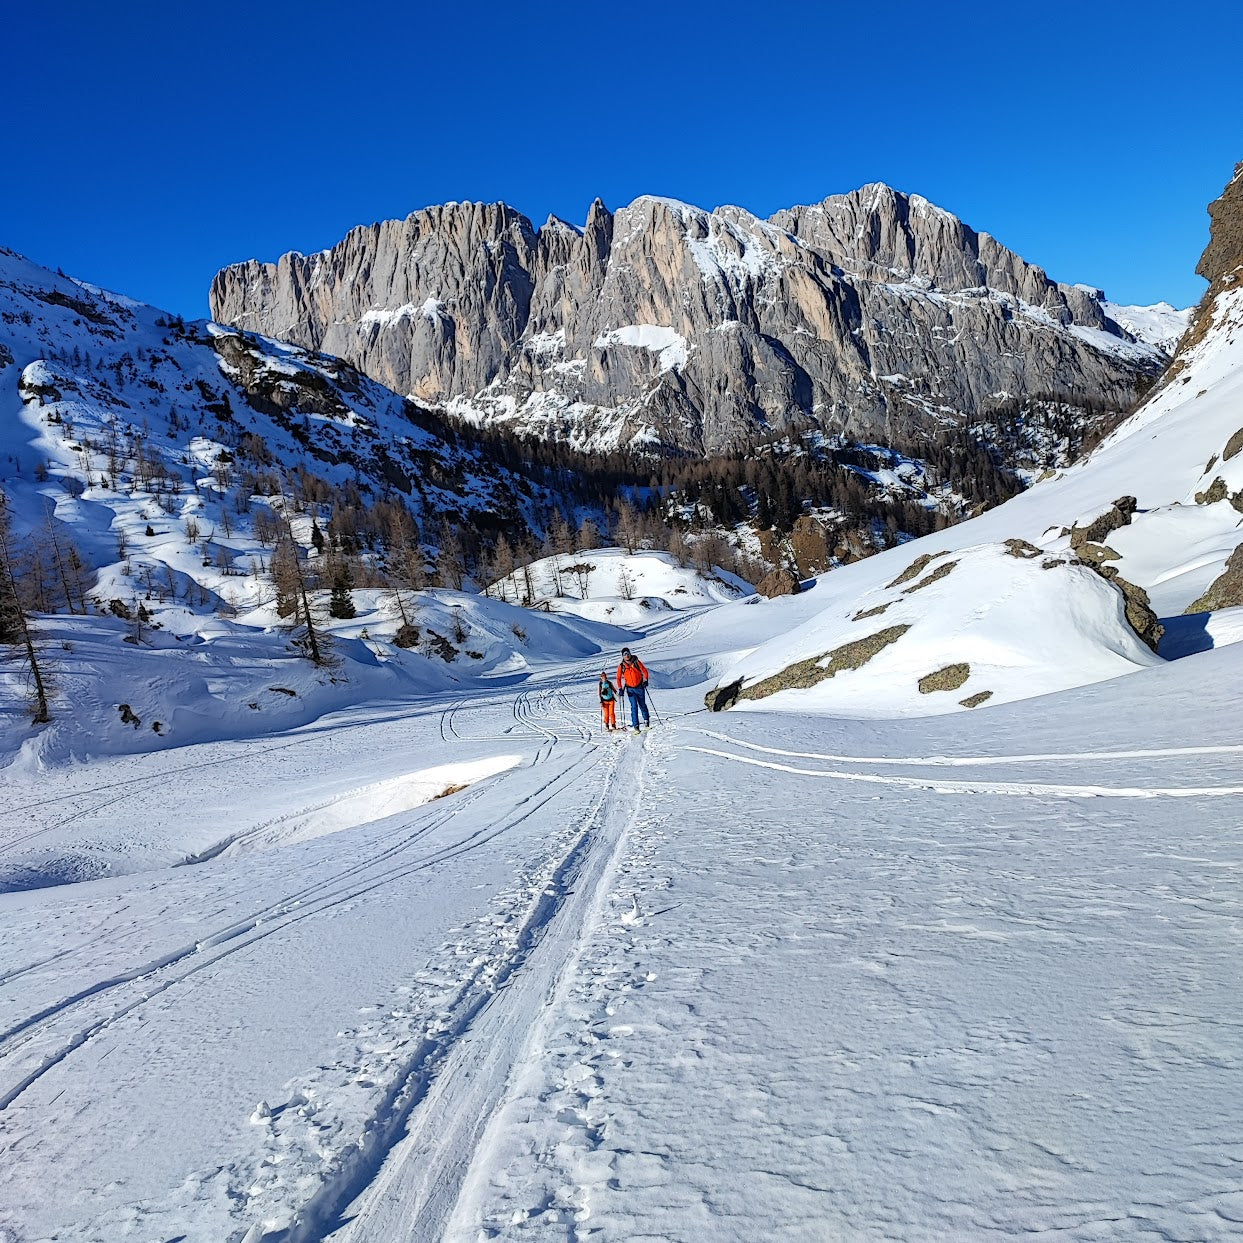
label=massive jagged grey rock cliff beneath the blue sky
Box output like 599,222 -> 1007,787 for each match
211,185 -> 1167,452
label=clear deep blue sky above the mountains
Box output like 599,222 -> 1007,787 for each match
0,0 -> 1243,316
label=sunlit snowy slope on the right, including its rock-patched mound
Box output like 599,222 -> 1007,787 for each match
720,275 -> 1243,713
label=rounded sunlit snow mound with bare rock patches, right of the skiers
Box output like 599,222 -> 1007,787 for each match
728,541 -> 1160,716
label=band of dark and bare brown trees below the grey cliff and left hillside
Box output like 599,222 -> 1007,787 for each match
0,345 -> 1128,712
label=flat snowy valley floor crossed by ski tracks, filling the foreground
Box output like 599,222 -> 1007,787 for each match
0,617 -> 1243,1243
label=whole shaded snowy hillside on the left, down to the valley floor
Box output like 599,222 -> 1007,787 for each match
0,251 -> 626,759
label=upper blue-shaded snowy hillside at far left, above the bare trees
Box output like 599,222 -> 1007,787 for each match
0,249 -> 530,525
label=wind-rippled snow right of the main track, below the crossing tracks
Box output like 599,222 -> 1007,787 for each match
454,722 -> 1243,1243
